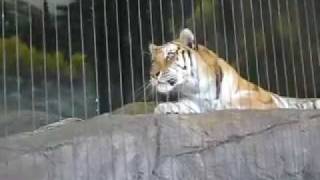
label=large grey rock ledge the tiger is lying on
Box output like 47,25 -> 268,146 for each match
0,110 -> 320,180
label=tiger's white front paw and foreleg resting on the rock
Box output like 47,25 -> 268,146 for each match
154,99 -> 201,114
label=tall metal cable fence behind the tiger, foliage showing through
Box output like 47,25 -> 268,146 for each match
0,0 -> 320,135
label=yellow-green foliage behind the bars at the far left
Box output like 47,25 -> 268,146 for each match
0,37 -> 86,78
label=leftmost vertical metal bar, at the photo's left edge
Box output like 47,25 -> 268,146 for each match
1,0 -> 8,133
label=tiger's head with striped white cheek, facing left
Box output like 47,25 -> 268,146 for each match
149,29 -> 201,94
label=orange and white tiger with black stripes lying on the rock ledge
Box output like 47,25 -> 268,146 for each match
149,28 -> 320,114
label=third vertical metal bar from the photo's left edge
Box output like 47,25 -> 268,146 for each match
28,3 -> 36,130
